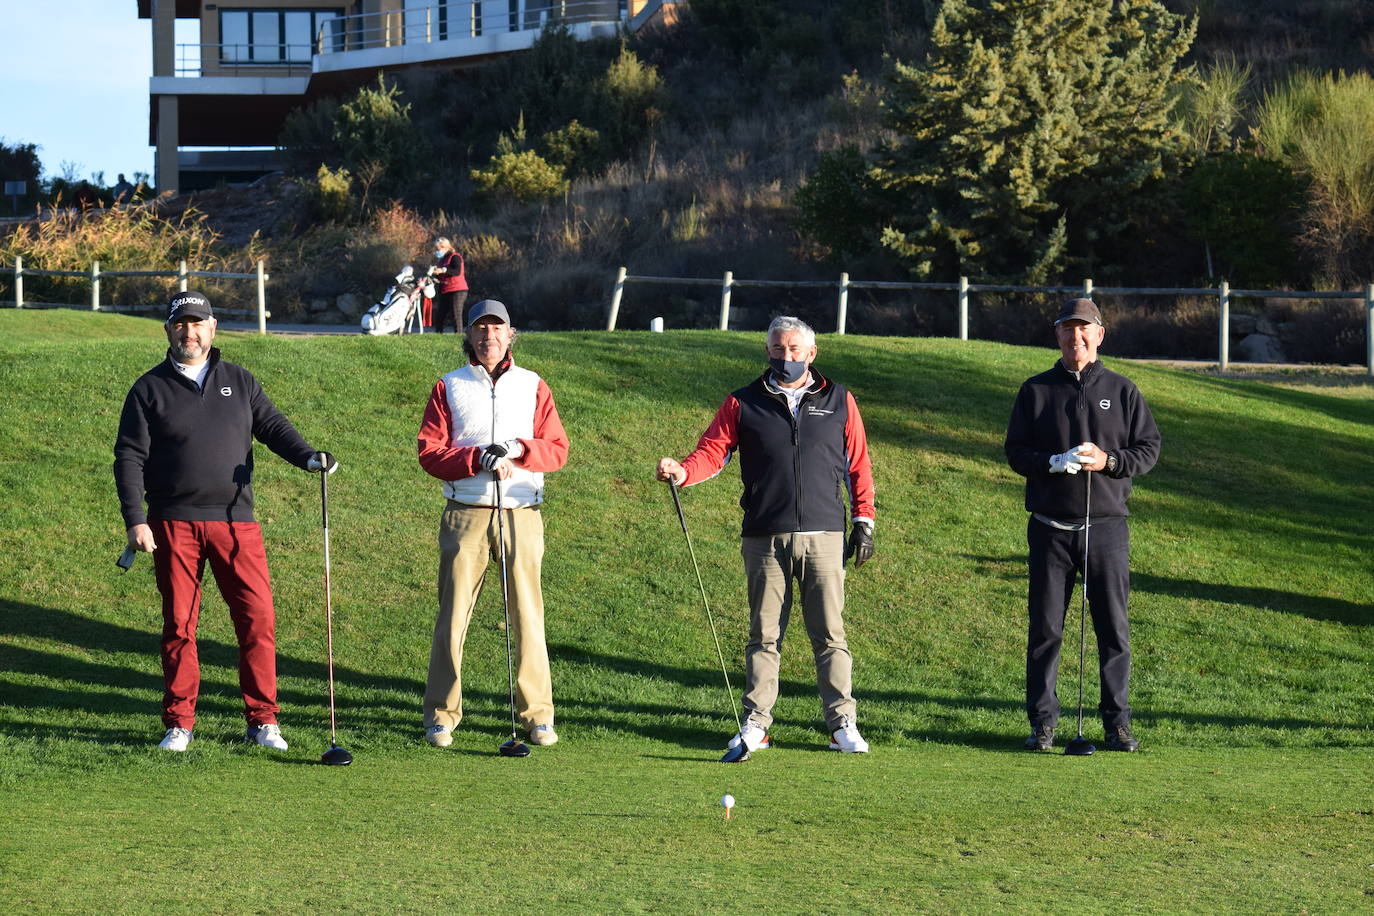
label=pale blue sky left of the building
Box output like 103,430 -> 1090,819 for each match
0,0 -> 195,184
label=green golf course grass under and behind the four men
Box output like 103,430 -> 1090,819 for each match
0,310 -> 1374,913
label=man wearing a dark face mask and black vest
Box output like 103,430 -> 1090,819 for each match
657,317 -> 874,754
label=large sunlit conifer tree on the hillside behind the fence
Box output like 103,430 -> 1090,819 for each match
872,0 -> 1195,283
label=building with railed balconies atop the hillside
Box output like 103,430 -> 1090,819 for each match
137,0 -> 680,191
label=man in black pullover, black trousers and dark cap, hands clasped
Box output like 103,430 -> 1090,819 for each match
1004,299 -> 1160,751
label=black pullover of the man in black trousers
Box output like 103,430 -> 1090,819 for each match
1003,363 -> 1160,522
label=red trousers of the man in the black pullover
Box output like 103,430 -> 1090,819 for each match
148,520 -> 279,729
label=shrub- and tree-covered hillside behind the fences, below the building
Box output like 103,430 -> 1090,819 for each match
8,0 -> 1374,363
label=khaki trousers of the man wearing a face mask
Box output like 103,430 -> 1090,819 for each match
739,531 -> 855,731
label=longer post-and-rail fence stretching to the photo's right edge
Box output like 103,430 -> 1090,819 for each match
606,268 -> 1374,378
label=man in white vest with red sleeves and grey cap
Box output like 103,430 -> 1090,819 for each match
418,299 -> 567,747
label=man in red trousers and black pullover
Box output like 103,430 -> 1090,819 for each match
114,291 -> 338,751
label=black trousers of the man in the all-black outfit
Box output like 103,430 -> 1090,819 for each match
1026,518 -> 1131,731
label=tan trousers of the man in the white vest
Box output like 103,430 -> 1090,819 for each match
425,500 -> 554,728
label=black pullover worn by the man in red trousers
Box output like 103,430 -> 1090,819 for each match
114,347 -> 315,527
